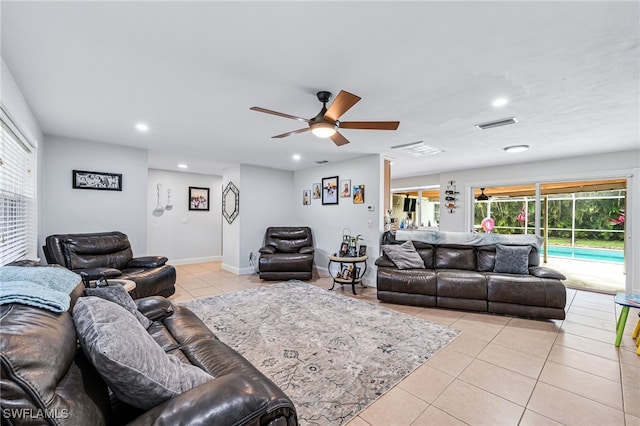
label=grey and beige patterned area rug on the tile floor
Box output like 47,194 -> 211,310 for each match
183,281 -> 460,426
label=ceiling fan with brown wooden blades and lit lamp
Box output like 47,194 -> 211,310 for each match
250,90 -> 400,146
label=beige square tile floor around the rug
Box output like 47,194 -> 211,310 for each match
171,262 -> 640,426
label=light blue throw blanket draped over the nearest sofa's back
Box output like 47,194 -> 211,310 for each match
0,266 -> 81,312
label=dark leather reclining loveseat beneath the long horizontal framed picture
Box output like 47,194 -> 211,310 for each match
43,231 -> 176,299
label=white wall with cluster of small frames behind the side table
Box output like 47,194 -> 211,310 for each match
293,155 -> 384,286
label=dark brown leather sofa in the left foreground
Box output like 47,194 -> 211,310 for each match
0,284 -> 298,426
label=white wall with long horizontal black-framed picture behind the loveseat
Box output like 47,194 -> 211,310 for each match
38,136 -> 147,256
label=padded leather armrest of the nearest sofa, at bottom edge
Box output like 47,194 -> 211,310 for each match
129,374 -> 282,425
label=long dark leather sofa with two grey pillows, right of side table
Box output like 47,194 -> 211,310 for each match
376,231 -> 566,319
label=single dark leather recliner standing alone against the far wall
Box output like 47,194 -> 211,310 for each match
258,226 -> 314,280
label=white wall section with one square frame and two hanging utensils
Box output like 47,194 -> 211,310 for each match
145,169 -> 222,265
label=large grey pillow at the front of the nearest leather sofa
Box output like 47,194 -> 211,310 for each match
73,296 -> 213,410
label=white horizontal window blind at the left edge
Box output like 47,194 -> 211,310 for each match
0,111 -> 36,265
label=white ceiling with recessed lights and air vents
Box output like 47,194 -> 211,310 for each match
0,0 -> 640,178
